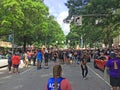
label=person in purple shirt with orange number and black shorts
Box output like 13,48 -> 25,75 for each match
106,53 -> 120,90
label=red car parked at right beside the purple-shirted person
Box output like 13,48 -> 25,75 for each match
94,56 -> 109,71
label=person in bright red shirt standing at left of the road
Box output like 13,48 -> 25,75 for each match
12,53 -> 20,73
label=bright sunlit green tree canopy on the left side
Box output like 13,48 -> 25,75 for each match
0,0 -> 65,49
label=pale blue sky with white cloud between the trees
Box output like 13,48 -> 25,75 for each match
44,0 -> 70,35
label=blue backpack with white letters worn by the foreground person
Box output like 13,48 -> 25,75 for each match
47,77 -> 64,90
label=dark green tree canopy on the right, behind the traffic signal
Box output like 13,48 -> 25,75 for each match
65,0 -> 120,47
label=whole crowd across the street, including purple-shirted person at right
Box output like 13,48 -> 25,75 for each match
3,48 -> 120,90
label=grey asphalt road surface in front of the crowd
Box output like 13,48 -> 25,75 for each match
0,59 -> 111,90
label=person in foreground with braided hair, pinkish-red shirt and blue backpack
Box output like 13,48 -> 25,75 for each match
45,65 -> 72,90
